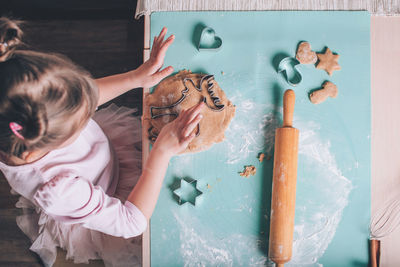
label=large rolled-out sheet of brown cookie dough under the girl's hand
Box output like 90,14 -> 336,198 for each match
145,70 -> 235,153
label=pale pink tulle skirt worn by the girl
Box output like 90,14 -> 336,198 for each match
16,104 -> 142,267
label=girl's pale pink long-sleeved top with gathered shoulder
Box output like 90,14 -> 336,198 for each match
0,120 -> 147,238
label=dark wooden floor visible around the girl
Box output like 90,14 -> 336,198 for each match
0,0 -> 143,266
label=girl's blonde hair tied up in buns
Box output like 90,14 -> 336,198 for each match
0,17 -> 98,157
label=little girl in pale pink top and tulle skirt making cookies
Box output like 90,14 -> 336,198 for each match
0,18 -> 203,266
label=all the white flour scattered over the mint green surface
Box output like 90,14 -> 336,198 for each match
175,96 -> 353,266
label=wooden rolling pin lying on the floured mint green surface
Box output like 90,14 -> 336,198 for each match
268,89 -> 299,267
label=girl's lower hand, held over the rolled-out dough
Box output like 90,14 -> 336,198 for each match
153,102 -> 204,157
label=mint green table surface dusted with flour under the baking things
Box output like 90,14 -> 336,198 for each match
150,11 -> 371,266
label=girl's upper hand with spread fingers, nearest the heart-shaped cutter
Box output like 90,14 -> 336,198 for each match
135,27 -> 175,88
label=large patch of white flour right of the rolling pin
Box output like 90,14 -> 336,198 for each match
287,121 -> 353,266
